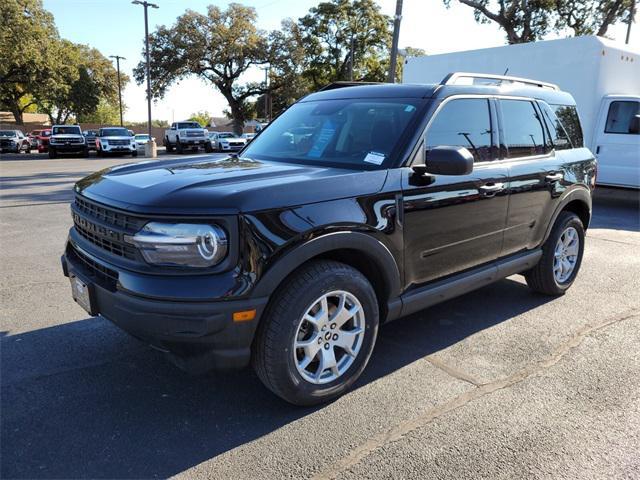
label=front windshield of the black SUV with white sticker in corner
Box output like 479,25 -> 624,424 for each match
242,98 -> 421,169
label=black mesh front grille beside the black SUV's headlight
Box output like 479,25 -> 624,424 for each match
71,196 -> 144,260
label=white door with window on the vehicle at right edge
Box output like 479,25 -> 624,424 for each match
594,97 -> 640,188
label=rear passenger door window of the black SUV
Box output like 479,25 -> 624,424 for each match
500,100 -> 547,158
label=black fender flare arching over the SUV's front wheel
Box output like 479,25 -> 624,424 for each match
251,231 -> 401,301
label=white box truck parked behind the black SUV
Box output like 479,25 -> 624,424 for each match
402,36 -> 640,188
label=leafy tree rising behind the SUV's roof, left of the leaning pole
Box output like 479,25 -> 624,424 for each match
298,0 -> 392,89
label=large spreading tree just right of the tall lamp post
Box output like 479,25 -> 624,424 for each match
134,3 -> 272,133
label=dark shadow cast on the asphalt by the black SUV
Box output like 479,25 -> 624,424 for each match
0,279 -> 549,478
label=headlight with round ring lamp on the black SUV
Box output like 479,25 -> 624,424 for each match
128,222 -> 227,267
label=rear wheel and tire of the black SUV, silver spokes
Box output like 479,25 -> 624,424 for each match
524,212 -> 584,296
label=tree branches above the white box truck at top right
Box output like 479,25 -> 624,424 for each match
443,0 -> 634,44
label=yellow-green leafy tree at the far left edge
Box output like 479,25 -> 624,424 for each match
0,0 -> 58,124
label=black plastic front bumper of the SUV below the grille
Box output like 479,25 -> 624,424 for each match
61,240 -> 268,369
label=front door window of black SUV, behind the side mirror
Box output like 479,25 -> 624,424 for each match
425,98 -> 493,162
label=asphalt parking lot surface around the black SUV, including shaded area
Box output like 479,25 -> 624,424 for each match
0,155 -> 640,479
